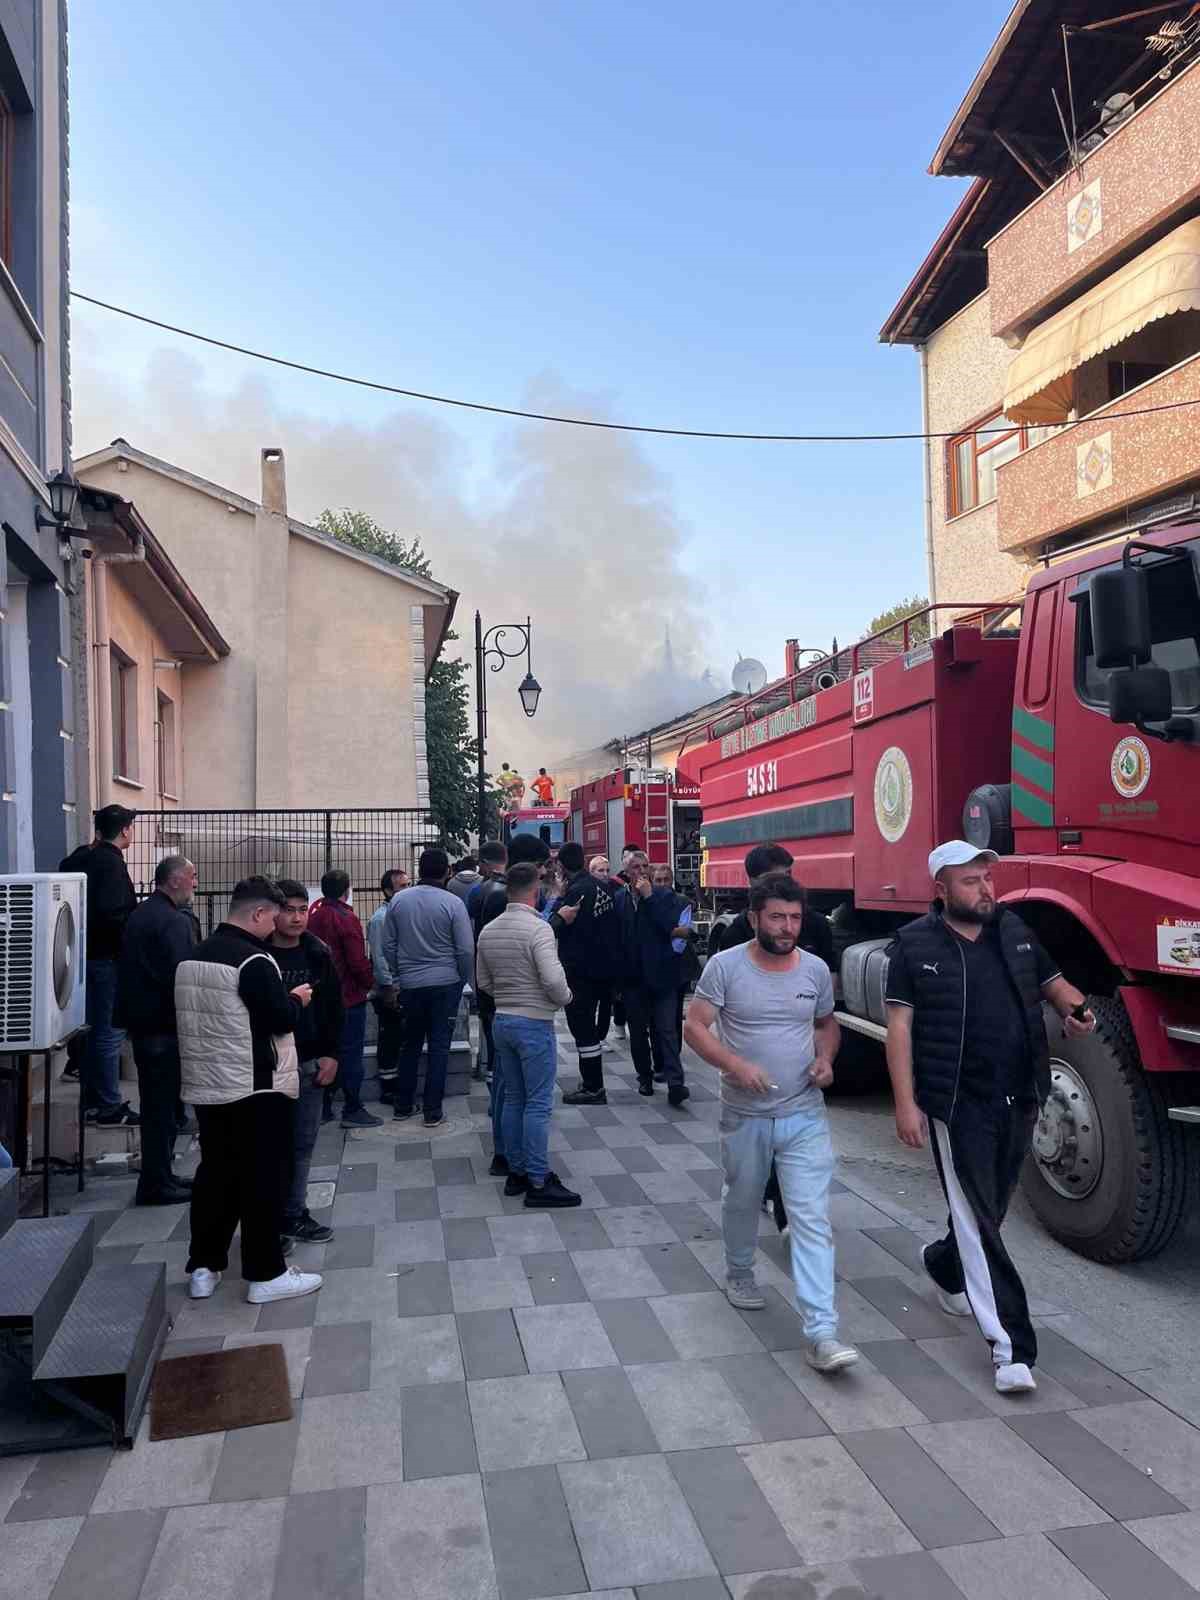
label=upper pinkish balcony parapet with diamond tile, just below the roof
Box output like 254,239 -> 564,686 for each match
987,62 -> 1200,338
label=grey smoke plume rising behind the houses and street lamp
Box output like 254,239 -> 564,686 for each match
72,332 -> 715,770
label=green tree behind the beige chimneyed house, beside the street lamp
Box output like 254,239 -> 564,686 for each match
317,509 -> 499,851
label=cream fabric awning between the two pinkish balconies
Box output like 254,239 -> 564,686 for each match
1005,218 -> 1200,424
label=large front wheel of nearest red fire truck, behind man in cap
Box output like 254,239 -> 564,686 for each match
1021,997 -> 1195,1264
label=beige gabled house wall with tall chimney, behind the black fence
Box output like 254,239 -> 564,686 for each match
77,440 -> 458,810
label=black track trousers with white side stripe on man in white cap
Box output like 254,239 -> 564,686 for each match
925,1096 -> 1037,1366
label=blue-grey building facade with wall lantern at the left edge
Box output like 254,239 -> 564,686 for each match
0,0 -> 83,872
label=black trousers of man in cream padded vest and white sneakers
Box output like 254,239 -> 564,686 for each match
187,1091 -> 296,1283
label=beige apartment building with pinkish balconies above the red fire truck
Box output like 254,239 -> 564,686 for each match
880,0 -> 1200,605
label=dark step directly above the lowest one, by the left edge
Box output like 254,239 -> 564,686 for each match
0,1216 -> 96,1366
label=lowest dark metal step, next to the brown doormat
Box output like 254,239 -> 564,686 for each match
34,1261 -> 166,1445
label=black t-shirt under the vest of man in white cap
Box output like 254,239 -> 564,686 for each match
888,923 -> 1061,1101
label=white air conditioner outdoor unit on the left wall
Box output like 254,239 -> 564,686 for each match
0,872 -> 88,1053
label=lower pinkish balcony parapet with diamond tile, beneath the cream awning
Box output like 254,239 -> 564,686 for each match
997,347 -> 1200,555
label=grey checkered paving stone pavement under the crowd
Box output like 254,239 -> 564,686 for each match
0,1050 -> 1200,1600
